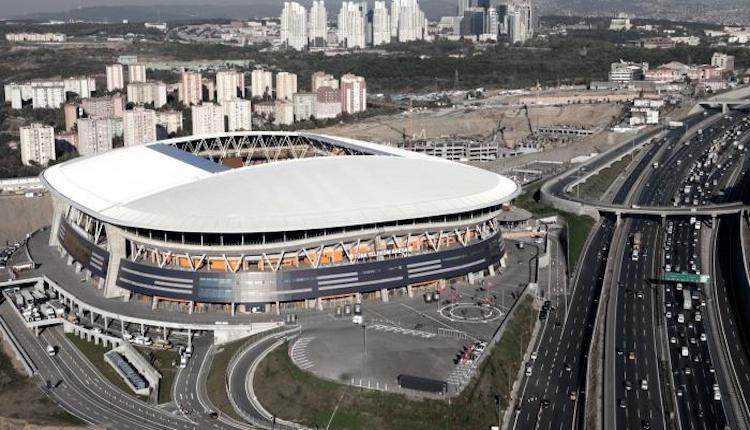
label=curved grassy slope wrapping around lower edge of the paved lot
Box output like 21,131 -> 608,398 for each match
254,297 -> 537,429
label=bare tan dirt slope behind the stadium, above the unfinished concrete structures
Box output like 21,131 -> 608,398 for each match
314,103 -> 622,146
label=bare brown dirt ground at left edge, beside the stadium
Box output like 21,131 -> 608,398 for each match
0,195 -> 52,246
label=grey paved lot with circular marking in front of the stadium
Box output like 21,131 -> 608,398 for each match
291,243 -> 537,394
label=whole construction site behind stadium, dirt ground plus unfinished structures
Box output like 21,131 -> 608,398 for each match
316,90 -> 624,162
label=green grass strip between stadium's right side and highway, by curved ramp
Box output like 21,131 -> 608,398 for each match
513,181 -> 595,273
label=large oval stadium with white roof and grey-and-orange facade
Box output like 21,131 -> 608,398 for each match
41,132 -> 520,312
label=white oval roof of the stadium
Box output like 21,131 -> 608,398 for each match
42,133 -> 520,233
